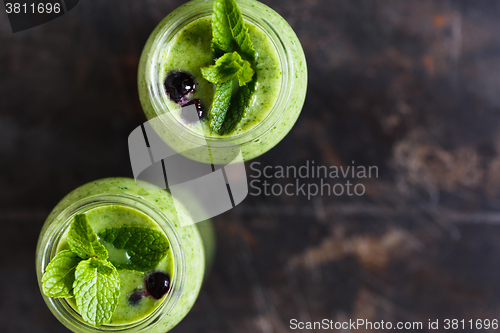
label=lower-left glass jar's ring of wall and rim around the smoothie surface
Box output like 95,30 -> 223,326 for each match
36,178 -> 215,333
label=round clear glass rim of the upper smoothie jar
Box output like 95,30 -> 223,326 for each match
145,0 -> 293,147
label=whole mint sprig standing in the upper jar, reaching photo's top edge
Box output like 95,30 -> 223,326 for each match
201,0 -> 256,135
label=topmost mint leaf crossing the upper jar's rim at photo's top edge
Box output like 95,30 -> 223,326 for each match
212,0 -> 256,60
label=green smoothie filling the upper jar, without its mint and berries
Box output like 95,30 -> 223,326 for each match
138,0 -> 307,164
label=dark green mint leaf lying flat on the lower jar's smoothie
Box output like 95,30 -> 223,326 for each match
99,227 -> 170,272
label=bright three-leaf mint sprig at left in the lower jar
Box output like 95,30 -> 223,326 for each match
42,214 -> 120,327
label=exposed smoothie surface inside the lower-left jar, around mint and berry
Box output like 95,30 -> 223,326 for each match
58,205 -> 174,325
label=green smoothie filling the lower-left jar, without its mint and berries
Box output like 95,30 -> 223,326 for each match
36,178 -> 215,333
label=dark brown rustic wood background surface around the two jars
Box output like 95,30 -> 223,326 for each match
0,0 -> 500,333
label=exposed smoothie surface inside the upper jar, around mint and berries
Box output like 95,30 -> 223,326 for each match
163,17 -> 281,136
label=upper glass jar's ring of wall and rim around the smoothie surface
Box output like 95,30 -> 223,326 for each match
138,0 -> 307,164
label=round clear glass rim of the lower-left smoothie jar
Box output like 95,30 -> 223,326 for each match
37,194 -> 186,333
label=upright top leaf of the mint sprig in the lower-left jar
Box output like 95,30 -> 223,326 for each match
68,214 -> 108,260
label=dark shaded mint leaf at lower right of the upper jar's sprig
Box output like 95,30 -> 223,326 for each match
219,78 -> 256,134
